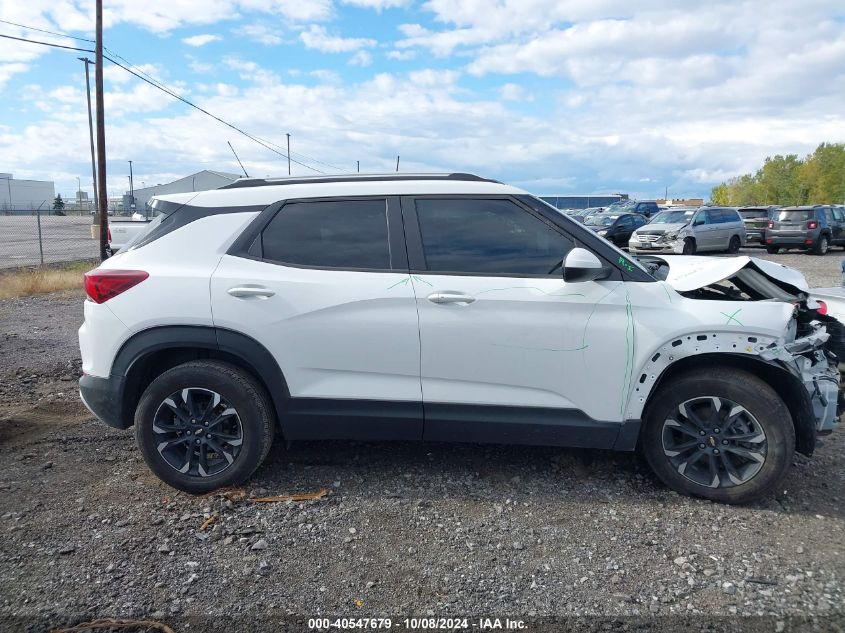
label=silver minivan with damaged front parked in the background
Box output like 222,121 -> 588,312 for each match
628,207 -> 746,255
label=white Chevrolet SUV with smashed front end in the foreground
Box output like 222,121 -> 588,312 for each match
79,174 -> 839,502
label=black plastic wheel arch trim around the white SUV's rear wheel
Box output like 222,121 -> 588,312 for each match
111,325 -> 290,432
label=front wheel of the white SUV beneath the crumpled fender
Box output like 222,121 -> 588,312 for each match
640,367 -> 795,503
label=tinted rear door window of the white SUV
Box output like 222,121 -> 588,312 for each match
261,200 -> 390,270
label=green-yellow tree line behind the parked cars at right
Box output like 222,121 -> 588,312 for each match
710,143 -> 845,207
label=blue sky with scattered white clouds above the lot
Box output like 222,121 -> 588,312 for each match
0,0 -> 845,198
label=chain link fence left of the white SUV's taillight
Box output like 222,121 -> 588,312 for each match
0,209 -> 99,269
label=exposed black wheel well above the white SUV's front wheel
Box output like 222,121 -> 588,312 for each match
642,353 -> 816,455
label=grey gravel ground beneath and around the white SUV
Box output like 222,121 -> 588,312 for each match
0,251 -> 845,633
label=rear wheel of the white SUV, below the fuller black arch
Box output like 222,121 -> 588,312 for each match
135,360 -> 275,494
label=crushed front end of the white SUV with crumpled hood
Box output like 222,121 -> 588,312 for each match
637,256 -> 845,455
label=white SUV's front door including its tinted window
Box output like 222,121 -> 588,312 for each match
402,197 -> 635,446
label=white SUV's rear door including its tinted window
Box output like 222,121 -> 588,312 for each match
211,198 -> 422,439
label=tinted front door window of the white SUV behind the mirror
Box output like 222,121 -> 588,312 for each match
416,199 -> 574,276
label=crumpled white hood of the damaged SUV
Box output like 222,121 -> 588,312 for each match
638,255 -> 809,296
